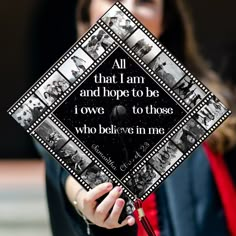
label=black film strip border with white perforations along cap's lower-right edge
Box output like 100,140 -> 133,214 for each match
123,94 -> 231,200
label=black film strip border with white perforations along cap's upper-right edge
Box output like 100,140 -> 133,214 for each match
98,2 -> 210,111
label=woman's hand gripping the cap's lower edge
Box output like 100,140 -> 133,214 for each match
65,176 -> 135,229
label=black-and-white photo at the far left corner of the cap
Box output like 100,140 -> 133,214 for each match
12,95 -> 47,129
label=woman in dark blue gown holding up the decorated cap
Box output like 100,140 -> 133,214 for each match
38,0 -> 235,236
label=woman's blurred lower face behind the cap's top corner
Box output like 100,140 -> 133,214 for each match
89,0 -> 163,38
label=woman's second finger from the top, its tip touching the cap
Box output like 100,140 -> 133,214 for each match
95,186 -> 122,221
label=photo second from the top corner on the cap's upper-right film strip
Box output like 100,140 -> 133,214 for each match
126,29 -> 161,64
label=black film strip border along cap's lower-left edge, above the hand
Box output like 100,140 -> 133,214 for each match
31,114 -> 134,200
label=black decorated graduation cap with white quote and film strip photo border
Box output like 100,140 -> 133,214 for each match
8,2 -> 230,232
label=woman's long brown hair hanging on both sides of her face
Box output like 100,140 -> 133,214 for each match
77,0 -> 236,152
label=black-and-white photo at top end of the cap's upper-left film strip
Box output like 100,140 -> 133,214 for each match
82,28 -> 114,60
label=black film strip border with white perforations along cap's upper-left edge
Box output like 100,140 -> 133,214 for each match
8,24 -> 117,133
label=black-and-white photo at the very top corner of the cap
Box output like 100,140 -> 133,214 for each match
102,6 -> 136,40
